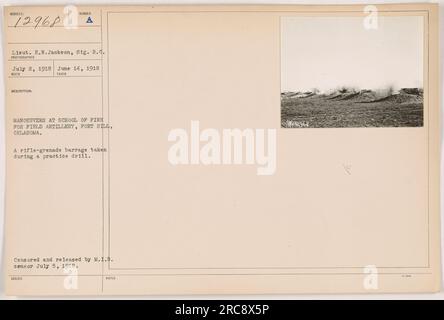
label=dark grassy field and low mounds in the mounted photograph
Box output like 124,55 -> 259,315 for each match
281,88 -> 424,128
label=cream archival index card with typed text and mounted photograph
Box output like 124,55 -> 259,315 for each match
4,4 -> 440,295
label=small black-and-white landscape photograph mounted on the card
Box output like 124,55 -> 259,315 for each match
281,16 -> 424,128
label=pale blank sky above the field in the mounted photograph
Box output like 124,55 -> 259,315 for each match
281,16 -> 424,92
